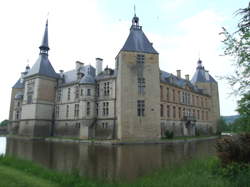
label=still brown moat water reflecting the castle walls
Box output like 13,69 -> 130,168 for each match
0,138 -> 215,180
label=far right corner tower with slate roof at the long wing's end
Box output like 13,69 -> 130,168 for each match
191,59 -> 220,133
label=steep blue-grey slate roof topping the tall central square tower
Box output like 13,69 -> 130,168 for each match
121,17 -> 158,54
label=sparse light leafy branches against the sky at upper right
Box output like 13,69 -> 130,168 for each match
221,3 -> 250,94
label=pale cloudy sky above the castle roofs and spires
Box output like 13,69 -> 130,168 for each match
0,0 -> 248,121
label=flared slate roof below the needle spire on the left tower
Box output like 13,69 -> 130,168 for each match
25,54 -> 60,78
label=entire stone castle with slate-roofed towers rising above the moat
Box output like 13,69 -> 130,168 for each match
9,15 -> 220,139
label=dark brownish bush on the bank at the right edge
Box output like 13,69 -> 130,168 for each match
216,133 -> 250,167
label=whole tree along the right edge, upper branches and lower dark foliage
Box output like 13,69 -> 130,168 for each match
221,3 -> 250,131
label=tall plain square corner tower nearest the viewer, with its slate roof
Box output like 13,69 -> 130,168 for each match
116,15 -> 160,139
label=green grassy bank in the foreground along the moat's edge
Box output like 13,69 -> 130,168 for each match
0,156 -> 250,187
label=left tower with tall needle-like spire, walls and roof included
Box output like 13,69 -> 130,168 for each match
19,21 -> 59,137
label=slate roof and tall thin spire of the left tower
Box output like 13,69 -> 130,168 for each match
26,20 -> 60,78
